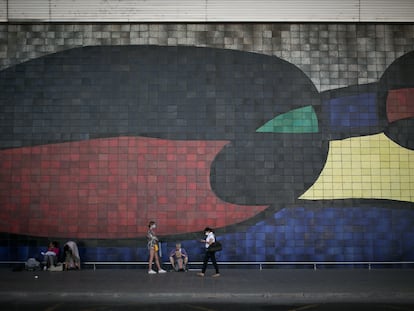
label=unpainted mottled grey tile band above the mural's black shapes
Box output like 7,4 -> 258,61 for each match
0,23 -> 414,91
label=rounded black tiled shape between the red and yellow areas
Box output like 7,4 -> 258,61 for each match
210,133 -> 328,205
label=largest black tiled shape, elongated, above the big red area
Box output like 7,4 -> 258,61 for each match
0,46 -> 319,149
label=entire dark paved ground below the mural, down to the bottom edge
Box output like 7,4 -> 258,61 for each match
0,269 -> 414,311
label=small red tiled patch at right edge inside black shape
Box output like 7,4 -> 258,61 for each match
387,88 -> 414,122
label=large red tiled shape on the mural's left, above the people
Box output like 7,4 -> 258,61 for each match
0,137 -> 267,239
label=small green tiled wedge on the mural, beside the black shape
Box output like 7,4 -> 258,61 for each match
256,106 -> 319,133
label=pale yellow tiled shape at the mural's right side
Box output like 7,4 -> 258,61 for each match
300,133 -> 414,202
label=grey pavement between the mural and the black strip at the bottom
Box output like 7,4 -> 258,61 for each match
0,267 -> 414,304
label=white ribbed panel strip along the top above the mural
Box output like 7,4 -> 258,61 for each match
0,0 -> 414,23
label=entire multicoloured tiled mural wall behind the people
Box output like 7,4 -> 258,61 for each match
0,24 -> 414,261
